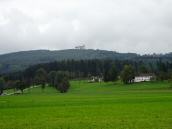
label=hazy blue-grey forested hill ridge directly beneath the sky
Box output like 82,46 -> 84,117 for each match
0,49 -> 172,73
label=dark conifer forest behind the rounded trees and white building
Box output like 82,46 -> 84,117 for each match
23,59 -> 172,80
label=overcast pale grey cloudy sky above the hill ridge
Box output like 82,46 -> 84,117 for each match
0,0 -> 172,54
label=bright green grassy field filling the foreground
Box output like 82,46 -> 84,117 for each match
0,81 -> 172,129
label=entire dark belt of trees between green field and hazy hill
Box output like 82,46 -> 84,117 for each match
0,59 -> 172,94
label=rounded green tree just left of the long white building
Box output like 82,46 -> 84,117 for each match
121,65 -> 135,84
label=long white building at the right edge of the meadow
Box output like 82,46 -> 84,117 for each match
134,75 -> 153,82
